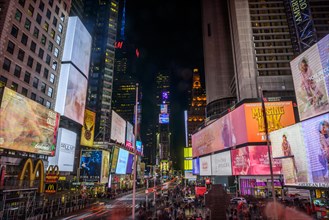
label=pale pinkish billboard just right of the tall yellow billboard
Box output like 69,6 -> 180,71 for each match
111,110 -> 126,144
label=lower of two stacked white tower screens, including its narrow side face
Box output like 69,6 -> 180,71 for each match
55,64 -> 88,125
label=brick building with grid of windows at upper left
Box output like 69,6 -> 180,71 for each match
0,0 -> 70,109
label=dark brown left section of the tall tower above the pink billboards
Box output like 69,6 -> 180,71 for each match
202,0 -> 236,117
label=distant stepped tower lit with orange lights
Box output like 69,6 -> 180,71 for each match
187,69 -> 207,147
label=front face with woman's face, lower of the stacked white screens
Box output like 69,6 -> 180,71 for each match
64,66 -> 88,124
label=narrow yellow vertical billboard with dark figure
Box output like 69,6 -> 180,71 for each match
80,109 -> 96,147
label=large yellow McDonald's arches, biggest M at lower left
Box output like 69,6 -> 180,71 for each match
18,158 -> 45,193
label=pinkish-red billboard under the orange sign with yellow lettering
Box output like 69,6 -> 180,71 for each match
231,146 -> 281,175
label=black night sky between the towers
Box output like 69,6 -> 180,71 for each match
126,0 -> 203,169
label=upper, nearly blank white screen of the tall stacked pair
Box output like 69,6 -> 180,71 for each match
62,17 -> 92,78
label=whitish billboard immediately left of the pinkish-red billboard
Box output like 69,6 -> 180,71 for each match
211,151 -> 232,176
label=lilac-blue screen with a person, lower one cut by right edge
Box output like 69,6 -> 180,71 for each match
302,114 -> 329,183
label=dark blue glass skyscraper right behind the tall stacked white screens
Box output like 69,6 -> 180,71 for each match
84,0 -> 119,140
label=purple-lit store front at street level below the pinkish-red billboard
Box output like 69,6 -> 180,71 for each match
239,176 -> 282,198
